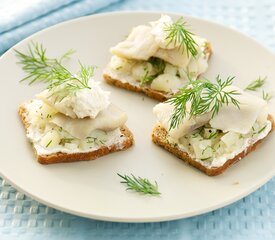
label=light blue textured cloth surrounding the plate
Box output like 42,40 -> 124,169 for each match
0,0 -> 275,240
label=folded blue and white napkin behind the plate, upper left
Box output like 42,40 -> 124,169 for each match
0,0 -> 120,54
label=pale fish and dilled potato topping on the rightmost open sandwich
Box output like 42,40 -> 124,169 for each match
153,86 -> 272,167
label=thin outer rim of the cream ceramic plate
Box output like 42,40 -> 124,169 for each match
0,11 -> 275,223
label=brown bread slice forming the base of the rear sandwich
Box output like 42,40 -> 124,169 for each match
103,44 -> 212,102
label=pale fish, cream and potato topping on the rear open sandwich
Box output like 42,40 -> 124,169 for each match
105,15 -> 209,93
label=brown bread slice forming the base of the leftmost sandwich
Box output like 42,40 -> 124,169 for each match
19,104 -> 134,164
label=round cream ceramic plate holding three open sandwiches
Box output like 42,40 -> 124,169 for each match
0,12 -> 275,222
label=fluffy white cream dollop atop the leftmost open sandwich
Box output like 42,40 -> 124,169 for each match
36,79 -> 110,118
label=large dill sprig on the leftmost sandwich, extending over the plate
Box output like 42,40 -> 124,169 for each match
15,43 -> 95,101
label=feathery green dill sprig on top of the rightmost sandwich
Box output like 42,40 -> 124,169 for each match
167,76 -> 240,130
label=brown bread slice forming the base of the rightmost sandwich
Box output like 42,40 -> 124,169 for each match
152,115 -> 275,176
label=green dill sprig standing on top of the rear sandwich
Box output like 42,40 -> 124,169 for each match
164,17 -> 198,57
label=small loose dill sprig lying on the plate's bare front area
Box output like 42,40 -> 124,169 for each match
117,173 -> 161,195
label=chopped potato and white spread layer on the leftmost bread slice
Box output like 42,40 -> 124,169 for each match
25,100 -> 127,155
